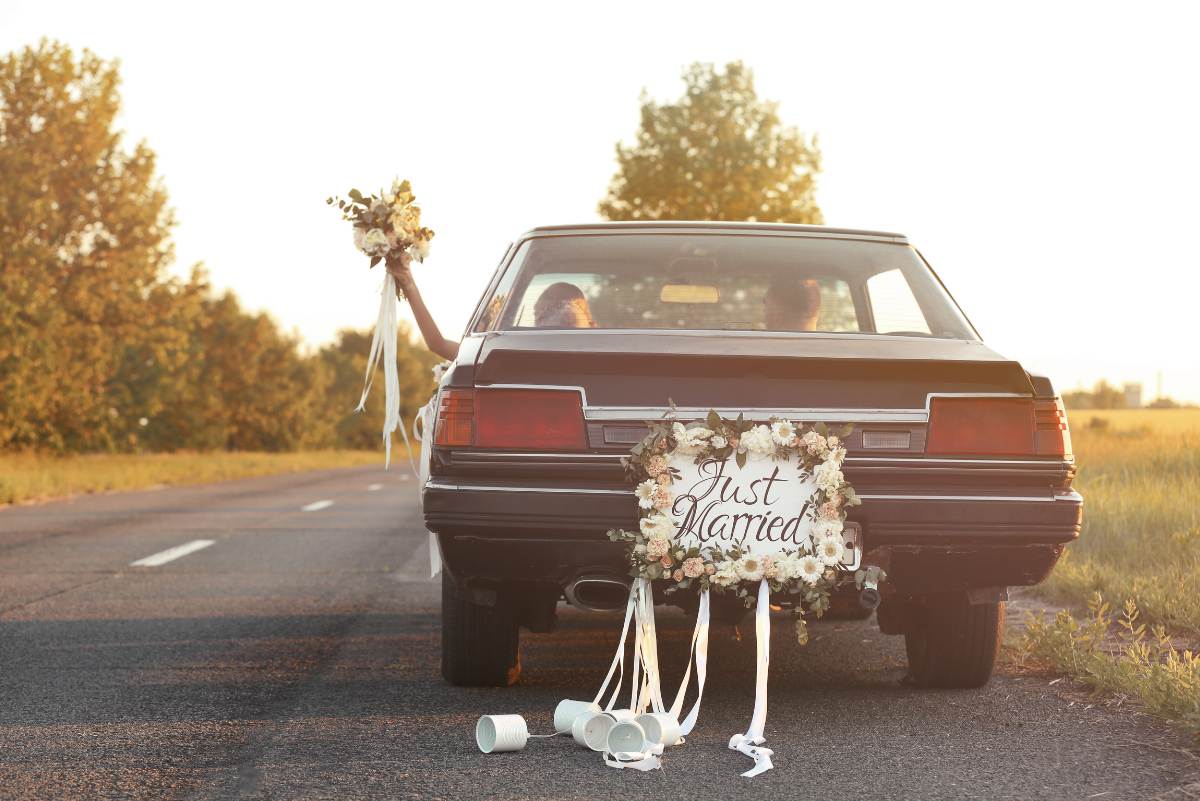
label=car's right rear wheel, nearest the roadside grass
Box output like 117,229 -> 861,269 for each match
905,598 -> 1004,688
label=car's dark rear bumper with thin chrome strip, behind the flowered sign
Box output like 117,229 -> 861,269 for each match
424,477 -> 1082,594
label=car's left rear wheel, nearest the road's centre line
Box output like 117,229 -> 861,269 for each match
442,571 -> 521,687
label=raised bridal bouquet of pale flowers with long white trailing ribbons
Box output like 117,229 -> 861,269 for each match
325,179 -> 433,465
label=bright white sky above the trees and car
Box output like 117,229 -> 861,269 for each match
0,0 -> 1200,401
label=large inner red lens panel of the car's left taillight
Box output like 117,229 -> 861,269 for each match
475,389 -> 588,451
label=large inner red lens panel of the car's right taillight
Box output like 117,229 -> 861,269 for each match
925,398 -> 1036,456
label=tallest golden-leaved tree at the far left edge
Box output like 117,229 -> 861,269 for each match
0,42 -> 180,450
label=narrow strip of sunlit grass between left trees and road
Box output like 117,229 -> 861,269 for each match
0,447 -> 407,504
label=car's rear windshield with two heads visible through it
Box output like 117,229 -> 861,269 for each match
473,233 -> 977,339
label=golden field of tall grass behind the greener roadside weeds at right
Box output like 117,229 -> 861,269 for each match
1039,409 -> 1200,633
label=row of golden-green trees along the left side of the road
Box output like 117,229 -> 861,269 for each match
0,42 -> 437,453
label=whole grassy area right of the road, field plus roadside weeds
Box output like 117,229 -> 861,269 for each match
1015,409 -> 1200,737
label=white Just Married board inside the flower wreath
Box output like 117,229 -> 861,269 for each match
671,453 -> 816,555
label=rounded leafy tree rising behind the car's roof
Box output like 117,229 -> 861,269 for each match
599,61 -> 823,224
